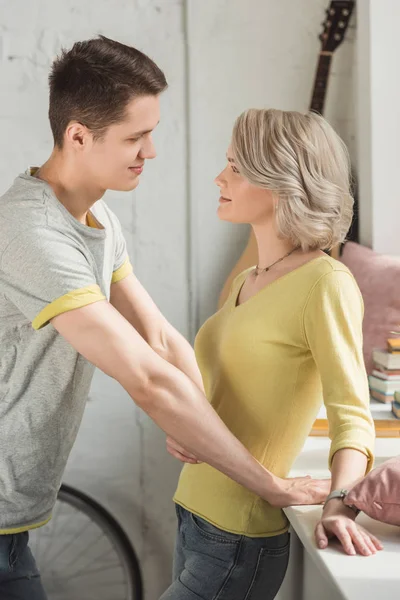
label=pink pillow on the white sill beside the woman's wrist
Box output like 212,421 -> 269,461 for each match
344,456 -> 400,526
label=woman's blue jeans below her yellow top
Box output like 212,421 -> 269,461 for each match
160,505 -> 290,600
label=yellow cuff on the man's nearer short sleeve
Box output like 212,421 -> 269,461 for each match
32,285 -> 106,329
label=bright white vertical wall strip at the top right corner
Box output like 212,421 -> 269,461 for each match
357,0 -> 400,256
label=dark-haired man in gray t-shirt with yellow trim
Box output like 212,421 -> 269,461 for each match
0,37 -> 329,600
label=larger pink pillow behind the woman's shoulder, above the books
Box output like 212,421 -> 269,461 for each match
341,242 -> 400,373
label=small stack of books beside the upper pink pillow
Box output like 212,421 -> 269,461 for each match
369,340 -> 400,403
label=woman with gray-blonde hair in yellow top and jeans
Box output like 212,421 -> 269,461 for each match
162,109 -> 381,600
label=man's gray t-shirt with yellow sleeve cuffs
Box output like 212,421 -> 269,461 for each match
0,174 -> 131,534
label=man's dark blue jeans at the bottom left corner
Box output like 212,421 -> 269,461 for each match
0,531 -> 47,600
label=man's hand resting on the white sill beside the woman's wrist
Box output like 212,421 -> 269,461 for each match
268,475 -> 331,508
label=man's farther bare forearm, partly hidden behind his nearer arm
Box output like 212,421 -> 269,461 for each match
110,273 -> 204,391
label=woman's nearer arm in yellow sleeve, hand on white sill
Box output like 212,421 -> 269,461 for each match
304,267 -> 380,555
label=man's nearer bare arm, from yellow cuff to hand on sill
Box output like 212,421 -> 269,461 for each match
51,301 -> 329,506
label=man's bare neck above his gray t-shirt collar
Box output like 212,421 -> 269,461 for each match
35,150 -> 105,224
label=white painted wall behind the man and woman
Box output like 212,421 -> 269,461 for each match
0,0 -> 355,600
